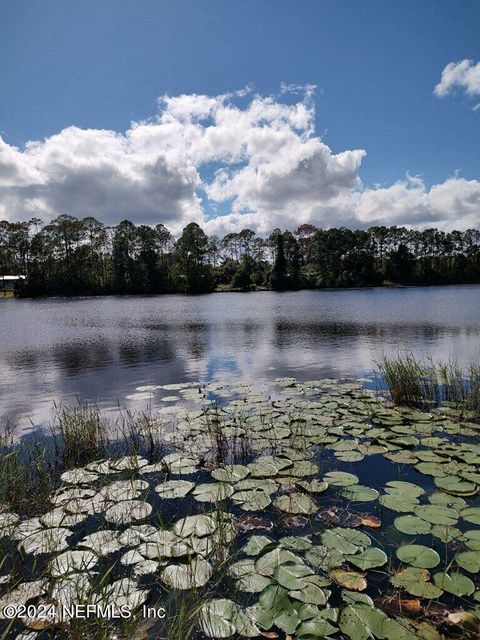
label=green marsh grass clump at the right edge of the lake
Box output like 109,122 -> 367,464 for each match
378,353 -> 480,419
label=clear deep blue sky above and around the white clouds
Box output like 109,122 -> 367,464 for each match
0,0 -> 480,235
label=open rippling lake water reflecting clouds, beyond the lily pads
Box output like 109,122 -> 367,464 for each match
0,286 -> 480,429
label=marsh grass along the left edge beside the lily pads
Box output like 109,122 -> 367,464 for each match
0,401 -> 165,516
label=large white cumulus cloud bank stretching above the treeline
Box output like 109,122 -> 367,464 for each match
0,86 -> 480,234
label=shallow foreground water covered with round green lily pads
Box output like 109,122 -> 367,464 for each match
0,377 -> 480,640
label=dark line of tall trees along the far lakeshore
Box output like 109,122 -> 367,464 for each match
0,215 -> 480,297
